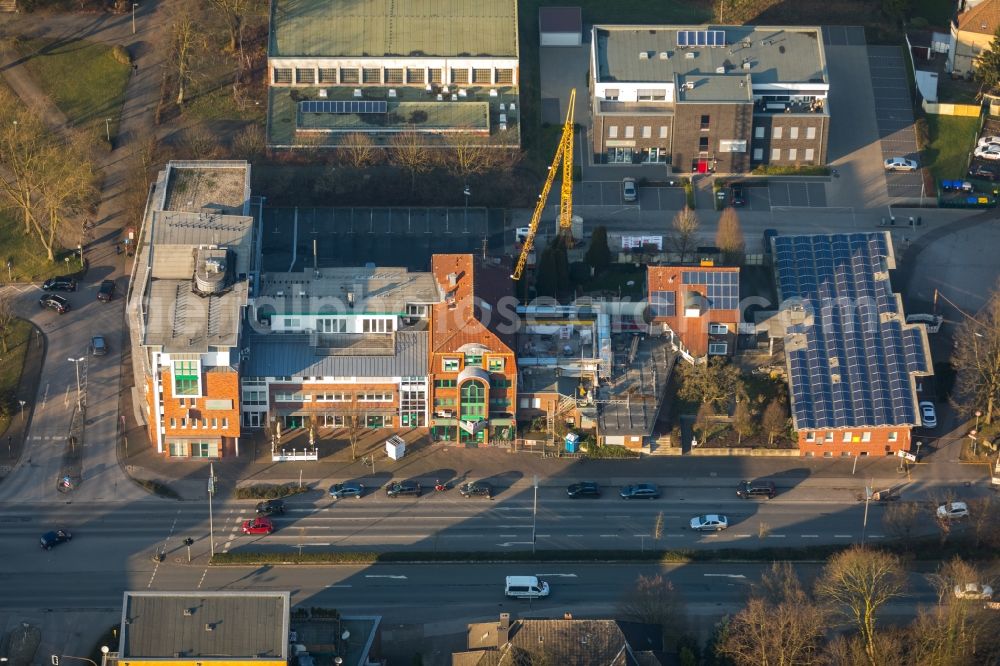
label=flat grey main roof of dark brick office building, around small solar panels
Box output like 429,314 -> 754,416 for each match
595,25 -> 828,85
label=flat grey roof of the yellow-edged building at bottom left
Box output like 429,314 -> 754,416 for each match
119,592 -> 289,661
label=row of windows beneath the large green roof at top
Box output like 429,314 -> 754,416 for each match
273,67 -> 514,86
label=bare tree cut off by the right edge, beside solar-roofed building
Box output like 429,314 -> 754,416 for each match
951,284 -> 1000,425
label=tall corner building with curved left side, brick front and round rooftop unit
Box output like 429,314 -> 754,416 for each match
126,162 -> 254,458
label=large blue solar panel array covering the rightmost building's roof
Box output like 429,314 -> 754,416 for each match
774,233 -> 930,429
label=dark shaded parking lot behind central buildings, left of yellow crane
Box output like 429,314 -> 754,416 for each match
261,208 -> 505,271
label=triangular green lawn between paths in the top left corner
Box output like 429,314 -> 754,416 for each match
20,39 -> 131,145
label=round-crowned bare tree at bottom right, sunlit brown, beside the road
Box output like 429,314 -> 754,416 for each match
816,546 -> 906,666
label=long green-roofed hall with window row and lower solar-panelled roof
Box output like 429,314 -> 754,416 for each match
268,0 -> 520,148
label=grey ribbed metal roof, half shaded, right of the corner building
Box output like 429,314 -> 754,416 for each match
247,331 -> 430,377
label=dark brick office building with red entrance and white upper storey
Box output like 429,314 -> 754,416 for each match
589,25 -> 830,173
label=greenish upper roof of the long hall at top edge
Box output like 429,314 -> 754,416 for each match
269,0 -> 517,57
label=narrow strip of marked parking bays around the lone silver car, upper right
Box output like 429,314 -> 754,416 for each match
868,46 -> 922,197
